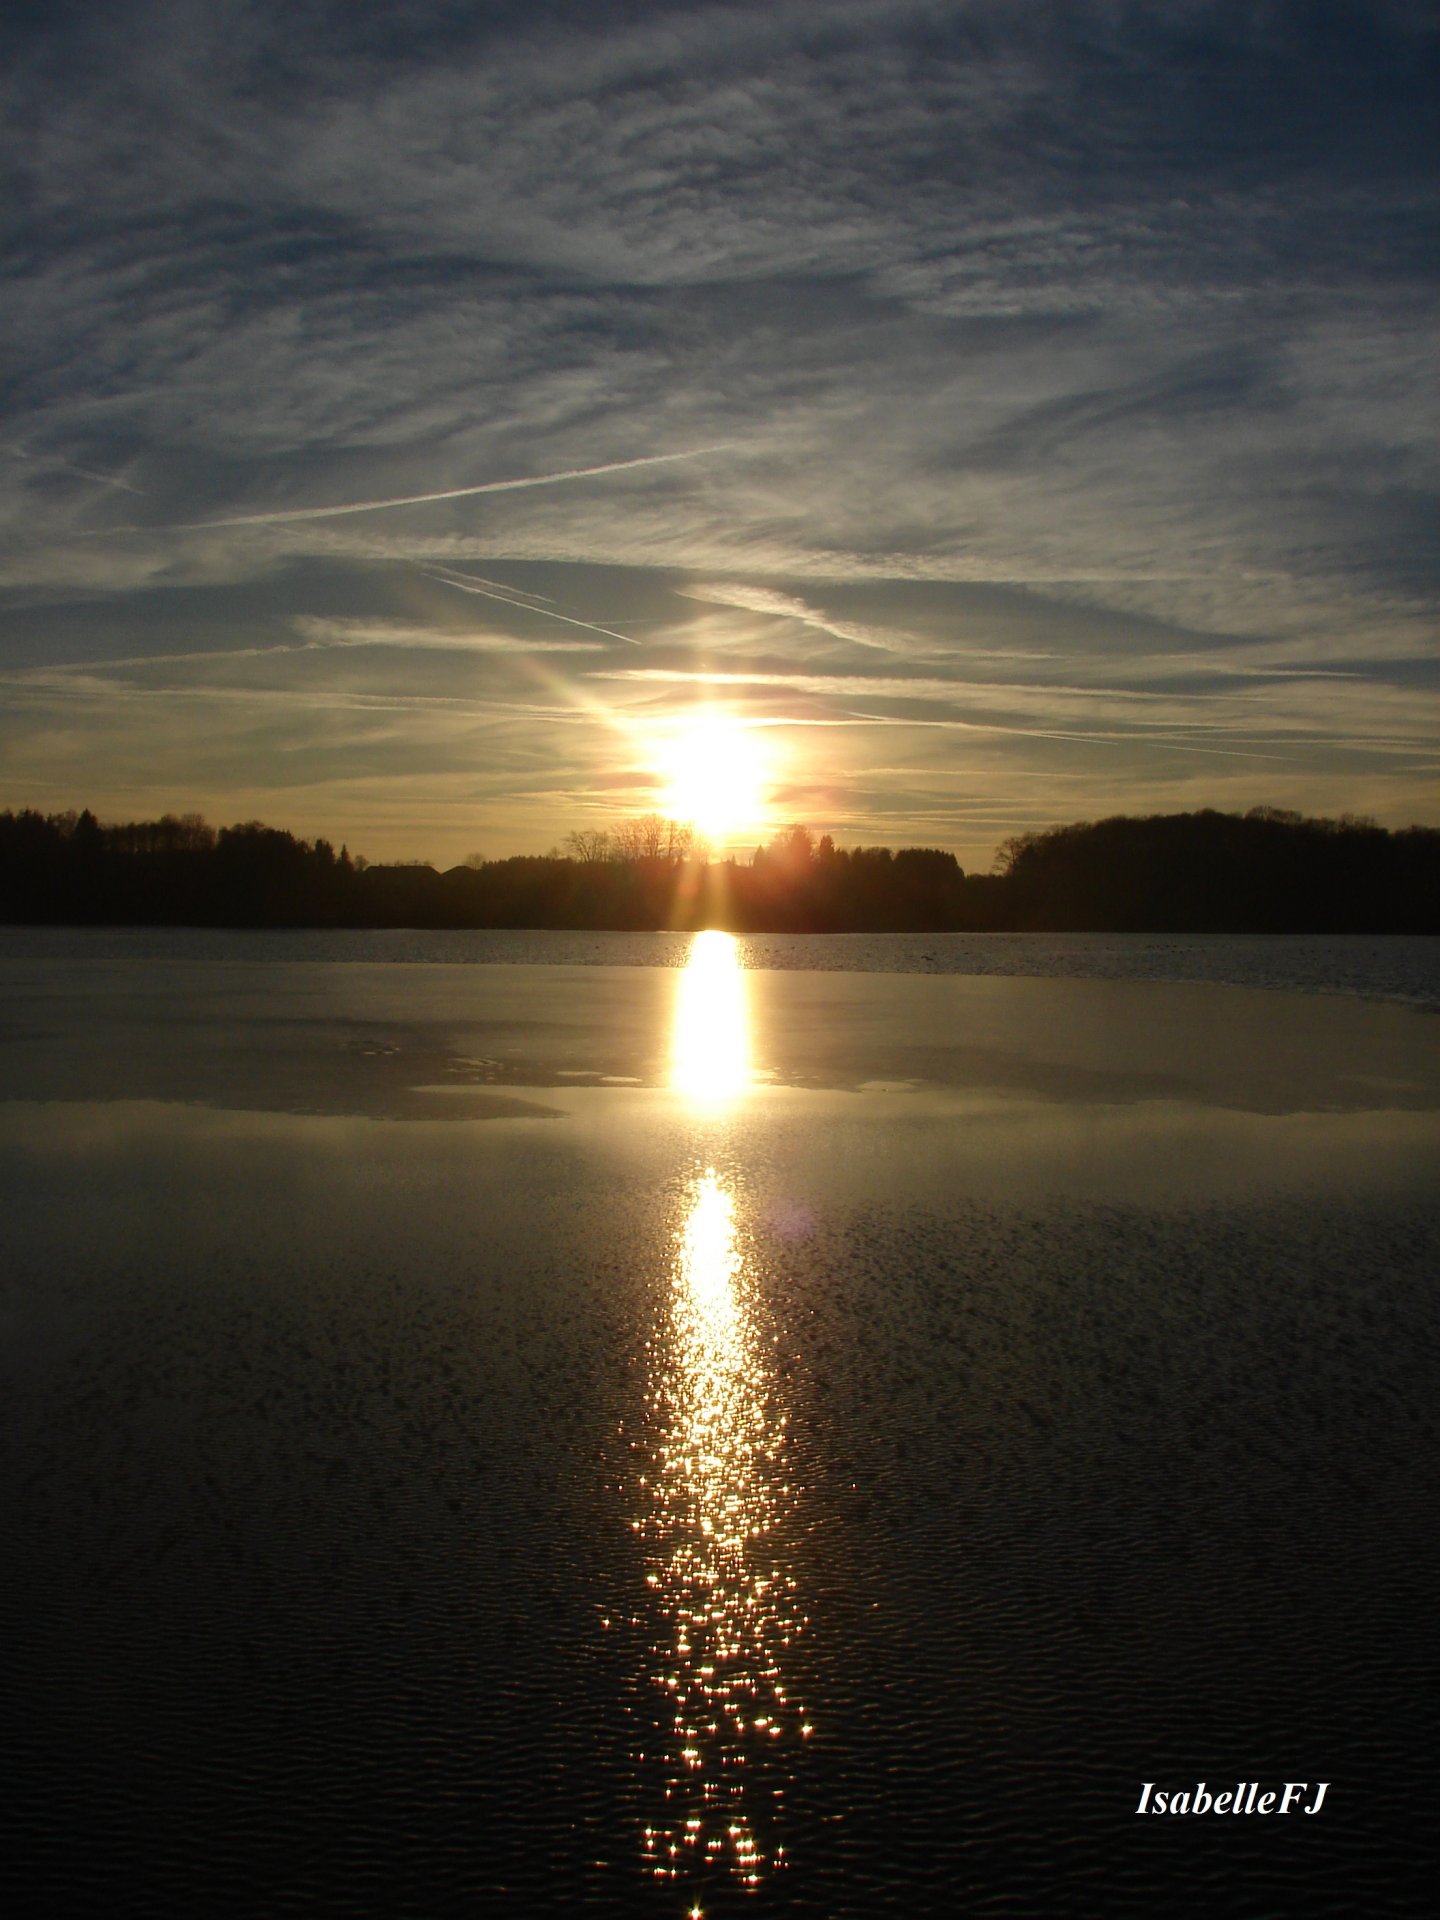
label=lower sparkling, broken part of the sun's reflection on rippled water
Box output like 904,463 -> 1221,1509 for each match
637,1169 -> 810,1887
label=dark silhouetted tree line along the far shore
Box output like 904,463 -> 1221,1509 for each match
0,806 -> 1440,933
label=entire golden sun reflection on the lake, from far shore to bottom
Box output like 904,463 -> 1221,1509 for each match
634,933 -> 810,1910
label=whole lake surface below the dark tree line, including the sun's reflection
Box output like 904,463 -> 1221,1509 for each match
0,931 -> 1440,1920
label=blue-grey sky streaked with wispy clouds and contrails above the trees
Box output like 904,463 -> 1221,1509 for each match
0,0 -> 1440,872
